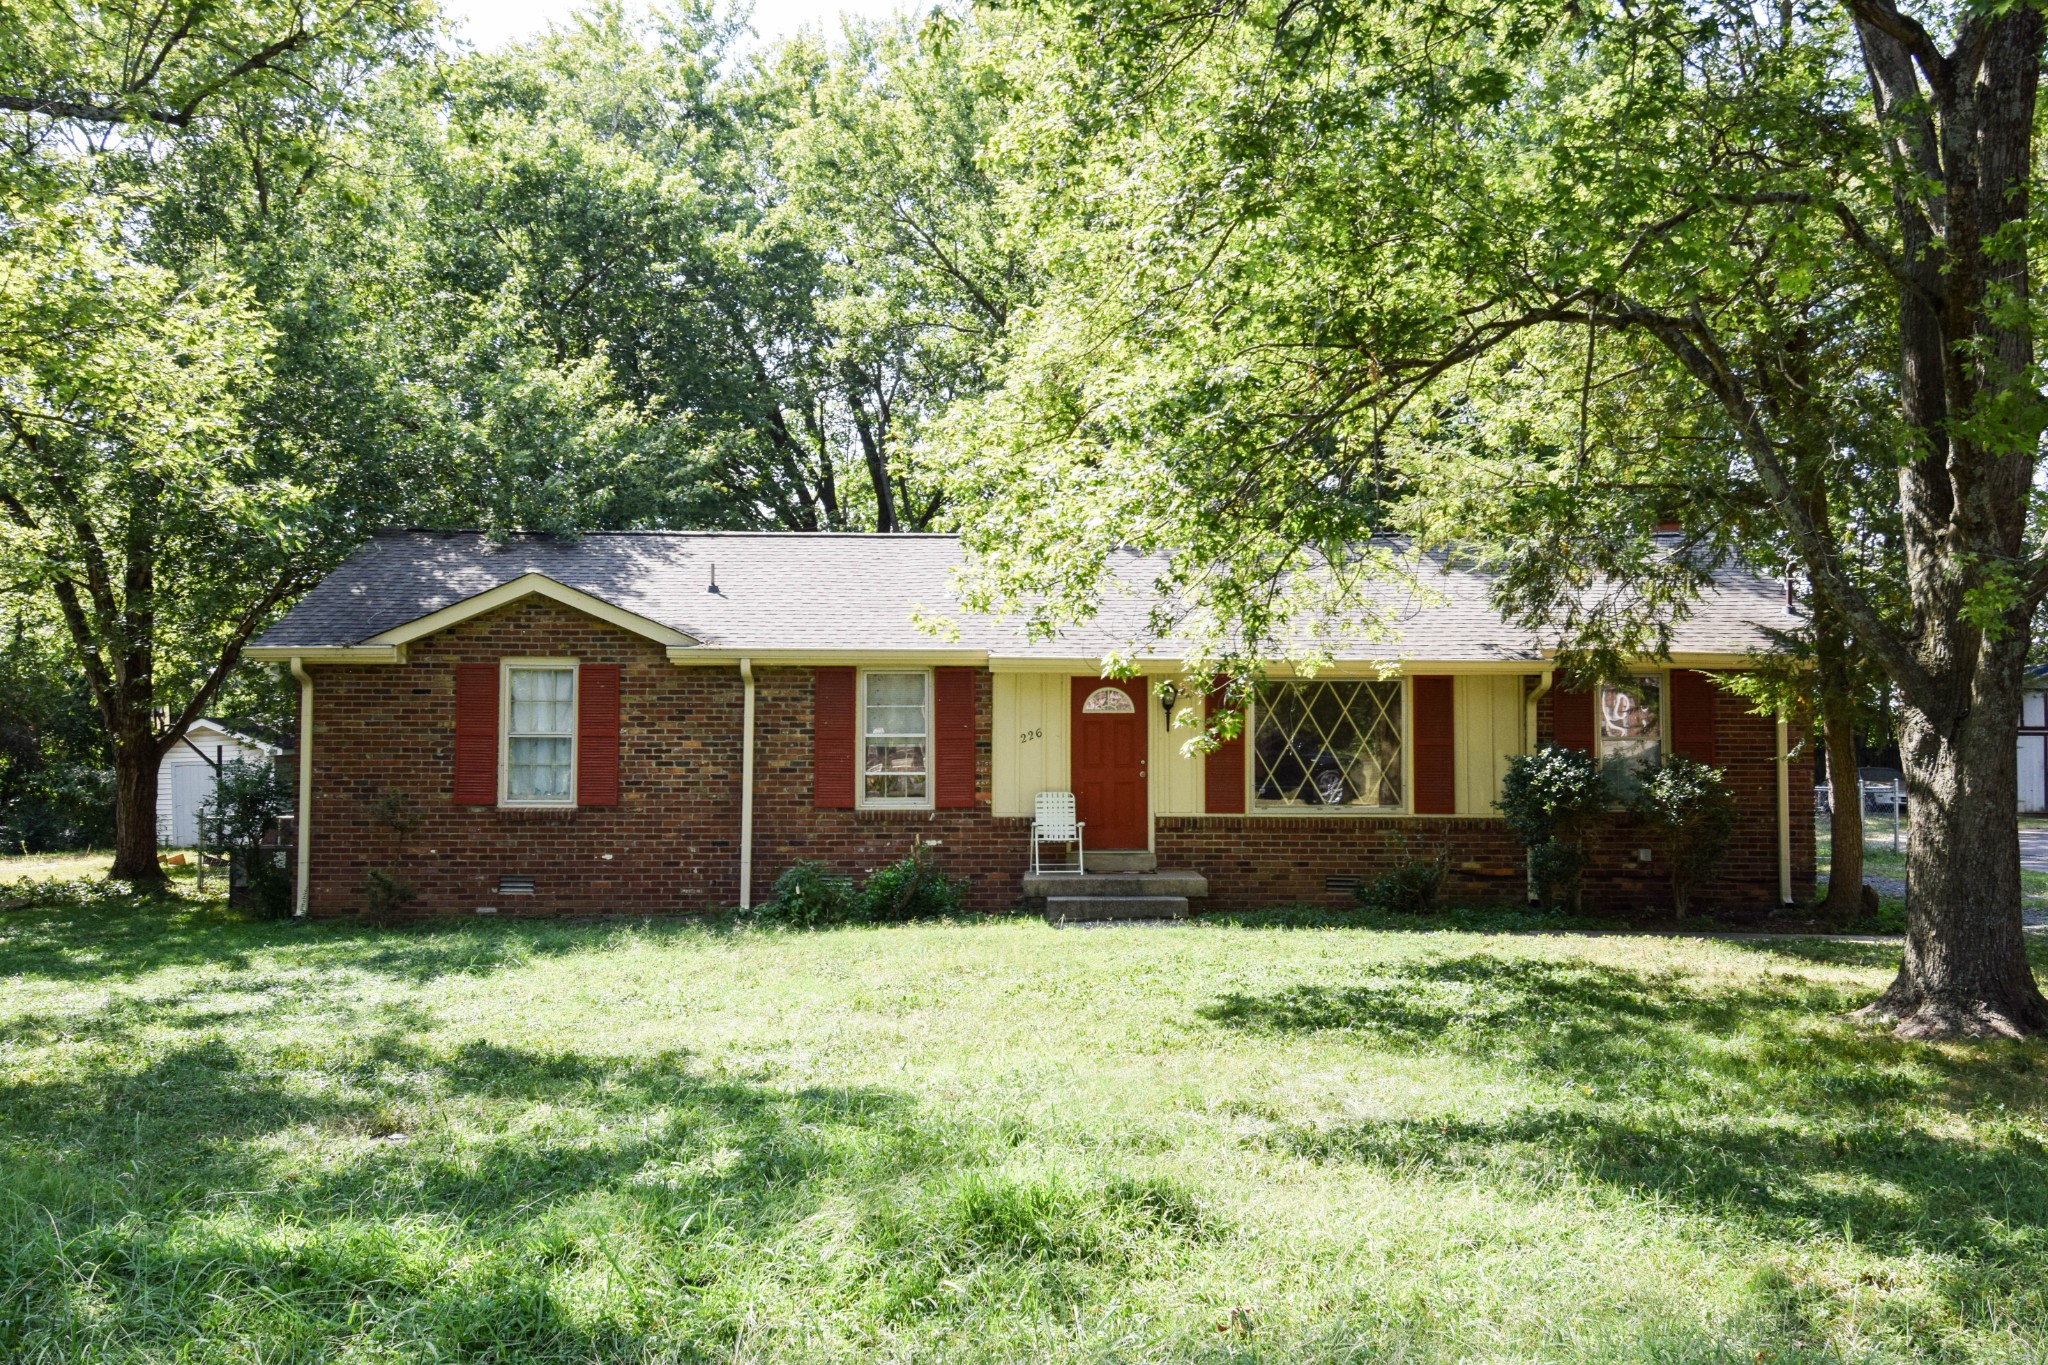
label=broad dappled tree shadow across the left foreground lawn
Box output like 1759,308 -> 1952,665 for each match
0,997 -> 1214,1361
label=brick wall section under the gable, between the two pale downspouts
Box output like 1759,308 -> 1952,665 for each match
309,598 -> 741,915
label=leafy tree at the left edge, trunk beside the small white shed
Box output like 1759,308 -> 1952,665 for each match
0,0 -> 428,882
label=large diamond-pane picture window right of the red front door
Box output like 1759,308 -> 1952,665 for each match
1251,681 -> 1401,810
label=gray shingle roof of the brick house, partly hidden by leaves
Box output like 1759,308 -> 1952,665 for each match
243,530 -> 1786,661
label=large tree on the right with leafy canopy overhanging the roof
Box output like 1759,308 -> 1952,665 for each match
952,0 -> 2048,1036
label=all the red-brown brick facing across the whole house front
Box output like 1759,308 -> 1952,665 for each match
299,618 -> 1812,915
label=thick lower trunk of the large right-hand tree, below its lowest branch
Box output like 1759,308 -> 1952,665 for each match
1862,687 -> 2048,1038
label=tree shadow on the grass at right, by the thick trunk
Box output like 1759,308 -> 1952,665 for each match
1200,943 -> 2048,1273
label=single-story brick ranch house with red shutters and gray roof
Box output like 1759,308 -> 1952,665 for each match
250,532 -> 1815,915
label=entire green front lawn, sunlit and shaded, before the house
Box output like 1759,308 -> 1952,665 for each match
0,902 -> 2048,1365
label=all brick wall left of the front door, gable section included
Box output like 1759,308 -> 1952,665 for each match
309,598 -> 1030,915
